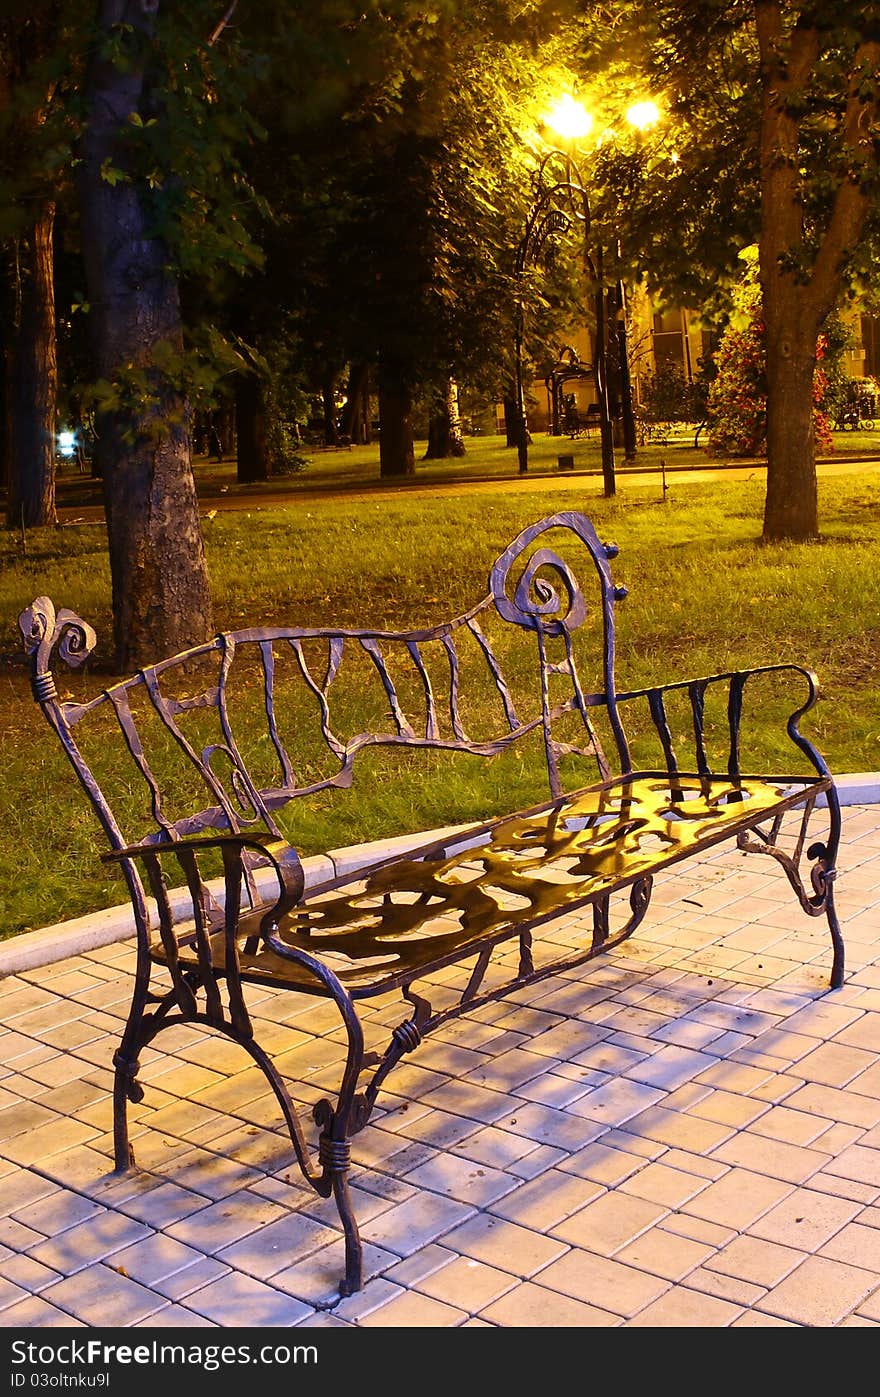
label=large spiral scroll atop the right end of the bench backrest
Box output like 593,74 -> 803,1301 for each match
489,510 -> 626,636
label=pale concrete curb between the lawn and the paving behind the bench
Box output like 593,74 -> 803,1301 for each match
0,771 -> 880,979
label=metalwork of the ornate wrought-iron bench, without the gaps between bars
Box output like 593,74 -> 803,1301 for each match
20,511 -> 844,1295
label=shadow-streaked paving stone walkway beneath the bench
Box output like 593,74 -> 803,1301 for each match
0,805 -> 880,1329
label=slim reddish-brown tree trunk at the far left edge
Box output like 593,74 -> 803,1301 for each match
7,201 -> 59,528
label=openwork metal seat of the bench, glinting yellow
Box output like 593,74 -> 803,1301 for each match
160,773 -> 830,999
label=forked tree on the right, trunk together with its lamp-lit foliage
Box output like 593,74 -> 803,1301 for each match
585,0 -> 880,539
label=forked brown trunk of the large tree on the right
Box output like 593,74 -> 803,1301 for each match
754,0 -> 880,538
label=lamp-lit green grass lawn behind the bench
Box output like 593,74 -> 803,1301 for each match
0,444 -> 880,936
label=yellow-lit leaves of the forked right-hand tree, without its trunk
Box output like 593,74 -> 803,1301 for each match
582,0 -> 880,313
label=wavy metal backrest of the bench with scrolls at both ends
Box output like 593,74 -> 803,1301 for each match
20,511 -> 629,849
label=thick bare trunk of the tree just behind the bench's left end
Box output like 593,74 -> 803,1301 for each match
80,0 -> 212,671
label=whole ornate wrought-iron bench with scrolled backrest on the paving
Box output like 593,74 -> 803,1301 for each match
20,513 -> 844,1294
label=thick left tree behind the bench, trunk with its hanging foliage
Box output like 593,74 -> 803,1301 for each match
80,0 -> 265,668
